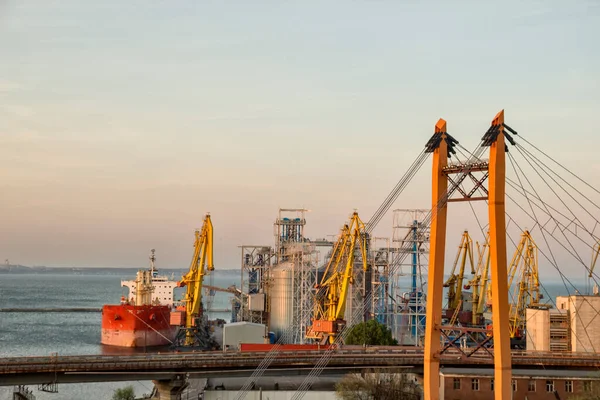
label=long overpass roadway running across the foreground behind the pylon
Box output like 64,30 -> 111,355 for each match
0,347 -> 600,386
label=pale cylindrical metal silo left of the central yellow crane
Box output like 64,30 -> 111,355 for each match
269,263 -> 294,340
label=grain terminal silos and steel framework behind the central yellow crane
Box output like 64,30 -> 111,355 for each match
232,208 -> 429,345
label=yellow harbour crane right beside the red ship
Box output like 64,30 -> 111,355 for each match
178,214 -> 214,346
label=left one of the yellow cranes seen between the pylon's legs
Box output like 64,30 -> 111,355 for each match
444,231 -> 475,322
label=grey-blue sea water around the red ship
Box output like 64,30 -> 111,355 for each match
0,270 -> 240,400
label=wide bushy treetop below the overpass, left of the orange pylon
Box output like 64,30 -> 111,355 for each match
335,370 -> 421,400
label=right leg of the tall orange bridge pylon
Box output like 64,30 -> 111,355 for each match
488,110 -> 512,400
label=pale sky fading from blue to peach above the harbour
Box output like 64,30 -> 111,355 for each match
0,0 -> 600,278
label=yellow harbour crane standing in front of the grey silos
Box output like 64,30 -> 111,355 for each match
306,212 -> 368,343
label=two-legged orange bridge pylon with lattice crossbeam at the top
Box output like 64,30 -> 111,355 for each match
424,110 -> 512,400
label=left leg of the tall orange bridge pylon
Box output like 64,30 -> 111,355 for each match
424,119 -> 448,400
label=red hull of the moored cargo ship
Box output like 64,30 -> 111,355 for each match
100,305 -> 176,347
